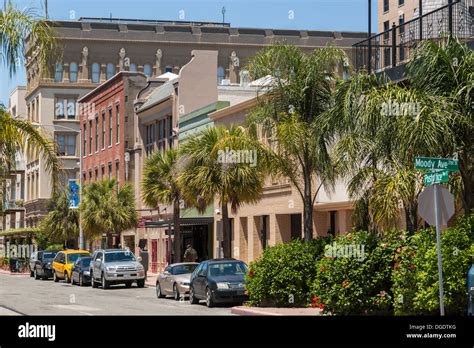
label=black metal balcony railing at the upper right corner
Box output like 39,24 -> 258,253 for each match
353,0 -> 473,72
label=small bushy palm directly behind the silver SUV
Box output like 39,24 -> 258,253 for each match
80,179 -> 138,248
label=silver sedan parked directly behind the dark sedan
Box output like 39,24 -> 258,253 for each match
156,262 -> 199,301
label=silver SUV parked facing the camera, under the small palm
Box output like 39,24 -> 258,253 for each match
90,249 -> 145,289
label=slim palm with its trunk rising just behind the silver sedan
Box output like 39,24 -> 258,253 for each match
141,149 -> 183,262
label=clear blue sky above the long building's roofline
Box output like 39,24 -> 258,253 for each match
0,0 -> 377,104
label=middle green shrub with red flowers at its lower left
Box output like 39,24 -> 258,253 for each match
310,232 -> 399,315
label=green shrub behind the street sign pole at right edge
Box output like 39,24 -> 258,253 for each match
392,215 -> 474,315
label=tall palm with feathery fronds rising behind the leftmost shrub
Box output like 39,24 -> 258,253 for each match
248,45 -> 347,241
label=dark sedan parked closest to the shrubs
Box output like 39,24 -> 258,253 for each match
189,259 -> 248,307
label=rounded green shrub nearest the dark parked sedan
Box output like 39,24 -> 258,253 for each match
246,238 -> 329,307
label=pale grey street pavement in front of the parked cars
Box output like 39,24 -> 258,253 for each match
0,274 -> 232,315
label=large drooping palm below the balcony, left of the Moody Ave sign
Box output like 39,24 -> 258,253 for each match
325,54 -> 459,233
